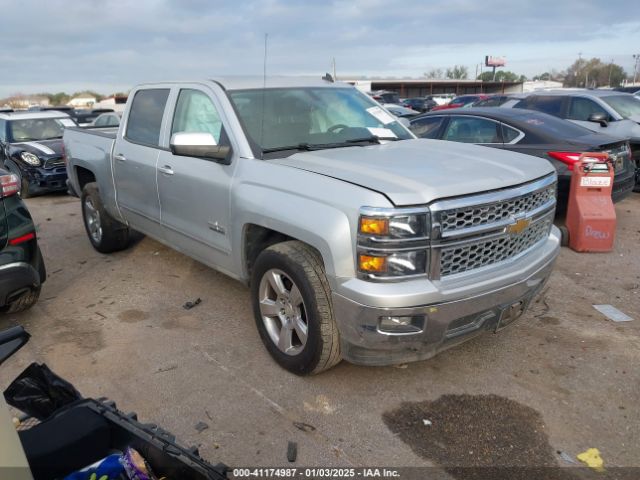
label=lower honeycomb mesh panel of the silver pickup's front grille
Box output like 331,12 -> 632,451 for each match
440,216 -> 553,276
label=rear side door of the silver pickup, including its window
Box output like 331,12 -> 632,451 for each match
112,88 -> 170,238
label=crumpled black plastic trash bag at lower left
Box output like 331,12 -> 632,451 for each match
4,363 -> 82,421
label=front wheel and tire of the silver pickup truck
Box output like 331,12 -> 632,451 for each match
251,241 -> 340,375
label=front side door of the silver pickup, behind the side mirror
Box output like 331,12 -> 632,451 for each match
158,84 -> 236,271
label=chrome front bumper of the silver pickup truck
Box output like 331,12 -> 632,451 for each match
333,227 -> 560,365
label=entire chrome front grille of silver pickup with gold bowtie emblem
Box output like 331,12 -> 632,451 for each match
429,175 -> 556,279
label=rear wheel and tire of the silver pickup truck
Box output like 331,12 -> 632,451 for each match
80,182 -> 129,253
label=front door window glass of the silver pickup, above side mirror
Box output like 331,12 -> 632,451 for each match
171,89 -> 222,144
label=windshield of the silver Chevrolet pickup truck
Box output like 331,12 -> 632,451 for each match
229,87 -> 414,153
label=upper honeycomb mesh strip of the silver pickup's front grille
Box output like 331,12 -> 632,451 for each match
440,184 -> 556,232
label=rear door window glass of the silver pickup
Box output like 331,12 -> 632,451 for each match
126,88 -> 169,147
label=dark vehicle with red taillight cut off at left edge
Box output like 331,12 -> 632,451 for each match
0,169 -> 47,313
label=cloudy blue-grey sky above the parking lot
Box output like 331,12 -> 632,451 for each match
0,0 -> 640,97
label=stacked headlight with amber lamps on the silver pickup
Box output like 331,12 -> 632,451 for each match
357,208 -> 431,280
